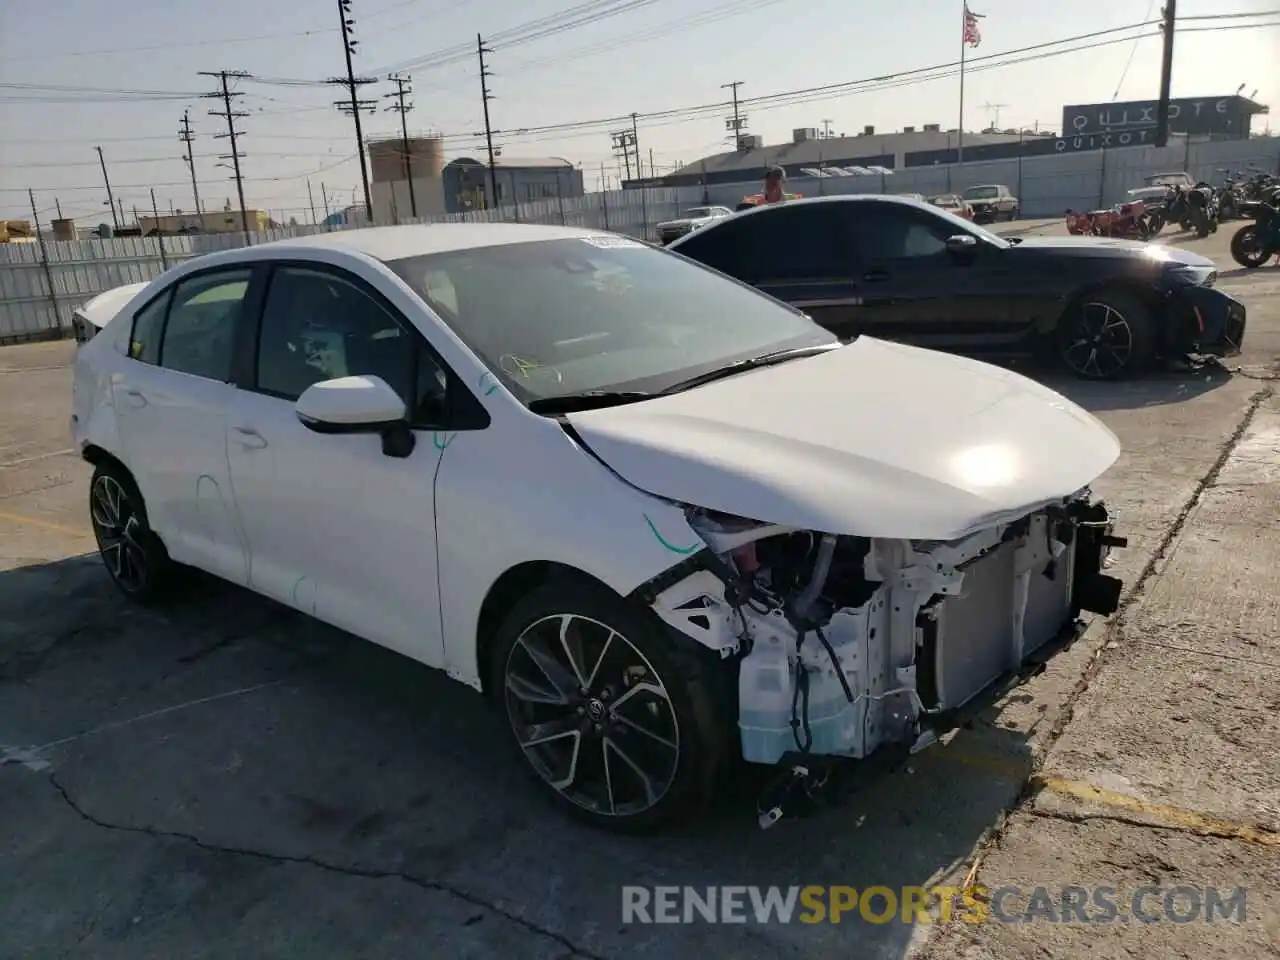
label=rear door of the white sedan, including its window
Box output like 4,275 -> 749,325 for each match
113,268 -> 252,584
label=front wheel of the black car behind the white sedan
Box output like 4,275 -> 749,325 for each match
1059,292 -> 1156,380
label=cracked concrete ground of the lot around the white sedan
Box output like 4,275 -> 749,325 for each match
0,234 -> 1280,960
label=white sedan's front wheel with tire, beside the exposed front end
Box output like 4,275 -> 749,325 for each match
490,577 -> 730,832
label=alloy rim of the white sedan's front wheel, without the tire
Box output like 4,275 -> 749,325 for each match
504,613 -> 680,817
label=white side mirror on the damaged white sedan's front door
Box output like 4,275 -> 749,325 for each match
293,376 -> 416,457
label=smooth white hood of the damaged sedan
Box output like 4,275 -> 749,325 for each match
568,337 -> 1120,540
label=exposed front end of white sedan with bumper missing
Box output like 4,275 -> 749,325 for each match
645,490 -> 1125,788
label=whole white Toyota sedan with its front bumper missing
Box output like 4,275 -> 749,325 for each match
72,224 -> 1124,828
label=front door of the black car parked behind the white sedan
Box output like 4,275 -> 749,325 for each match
844,200 -> 1021,353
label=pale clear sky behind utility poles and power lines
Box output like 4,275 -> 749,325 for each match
0,0 -> 1280,224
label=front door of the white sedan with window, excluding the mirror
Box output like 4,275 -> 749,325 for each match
227,265 -> 447,666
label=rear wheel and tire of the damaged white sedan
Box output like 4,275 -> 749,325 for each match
88,461 -> 177,604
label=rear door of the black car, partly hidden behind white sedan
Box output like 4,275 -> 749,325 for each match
678,202 -> 859,338
